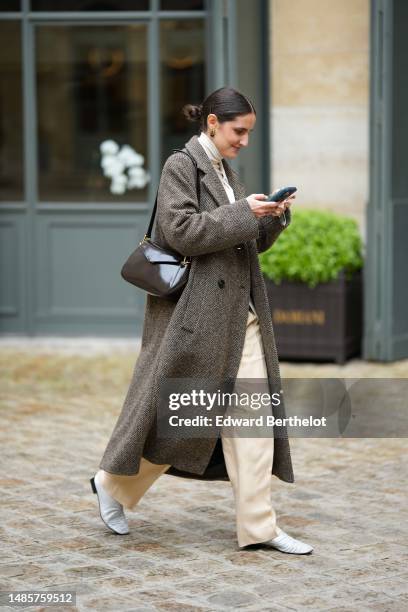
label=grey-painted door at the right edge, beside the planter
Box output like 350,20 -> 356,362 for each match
364,0 -> 408,361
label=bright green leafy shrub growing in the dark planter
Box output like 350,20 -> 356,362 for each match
259,210 -> 363,287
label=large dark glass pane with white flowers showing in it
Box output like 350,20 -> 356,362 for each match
36,24 -> 150,202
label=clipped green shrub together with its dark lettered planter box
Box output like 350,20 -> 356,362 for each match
259,210 -> 363,363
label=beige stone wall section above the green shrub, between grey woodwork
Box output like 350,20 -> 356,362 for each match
270,0 -> 370,235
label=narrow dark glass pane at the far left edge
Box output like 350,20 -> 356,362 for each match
0,21 -> 24,201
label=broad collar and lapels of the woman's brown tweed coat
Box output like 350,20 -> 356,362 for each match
185,136 -> 246,206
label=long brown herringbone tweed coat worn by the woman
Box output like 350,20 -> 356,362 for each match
100,136 -> 294,482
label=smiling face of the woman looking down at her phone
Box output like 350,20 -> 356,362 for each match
207,113 -> 256,159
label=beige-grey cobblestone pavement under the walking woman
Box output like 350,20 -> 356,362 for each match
0,341 -> 408,612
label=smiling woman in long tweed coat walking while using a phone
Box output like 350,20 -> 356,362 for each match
91,87 -> 313,554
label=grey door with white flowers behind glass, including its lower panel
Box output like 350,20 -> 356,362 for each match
31,22 -> 150,335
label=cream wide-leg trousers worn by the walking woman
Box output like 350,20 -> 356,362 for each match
99,310 -> 281,547
